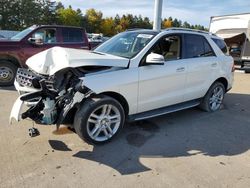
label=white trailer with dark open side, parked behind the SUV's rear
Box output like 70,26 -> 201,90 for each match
209,13 -> 250,73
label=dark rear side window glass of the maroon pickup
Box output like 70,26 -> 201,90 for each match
62,28 -> 84,42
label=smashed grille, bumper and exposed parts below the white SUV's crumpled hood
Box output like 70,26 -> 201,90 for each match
10,67 -> 98,127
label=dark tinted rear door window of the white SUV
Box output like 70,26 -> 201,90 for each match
184,34 -> 214,58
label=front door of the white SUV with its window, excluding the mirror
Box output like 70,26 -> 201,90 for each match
138,35 -> 187,113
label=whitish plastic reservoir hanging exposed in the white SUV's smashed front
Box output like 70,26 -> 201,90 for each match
41,98 -> 57,125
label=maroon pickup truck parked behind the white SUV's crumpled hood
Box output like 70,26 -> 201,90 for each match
0,25 -> 91,86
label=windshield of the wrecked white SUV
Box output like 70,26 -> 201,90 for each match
94,31 -> 155,59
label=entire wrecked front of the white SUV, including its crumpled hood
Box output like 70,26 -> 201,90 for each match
10,47 -> 129,129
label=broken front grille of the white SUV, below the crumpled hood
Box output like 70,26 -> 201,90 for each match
16,68 -> 54,90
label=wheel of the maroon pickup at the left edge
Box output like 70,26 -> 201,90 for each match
0,60 -> 18,86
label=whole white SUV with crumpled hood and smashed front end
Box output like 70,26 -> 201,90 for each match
10,28 -> 234,143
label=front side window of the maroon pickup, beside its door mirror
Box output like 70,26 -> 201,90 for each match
32,29 -> 57,44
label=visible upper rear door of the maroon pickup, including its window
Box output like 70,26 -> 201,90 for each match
60,27 -> 89,50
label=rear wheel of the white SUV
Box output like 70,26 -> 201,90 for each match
200,82 -> 225,112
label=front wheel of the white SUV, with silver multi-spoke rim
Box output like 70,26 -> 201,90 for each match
74,96 -> 125,144
